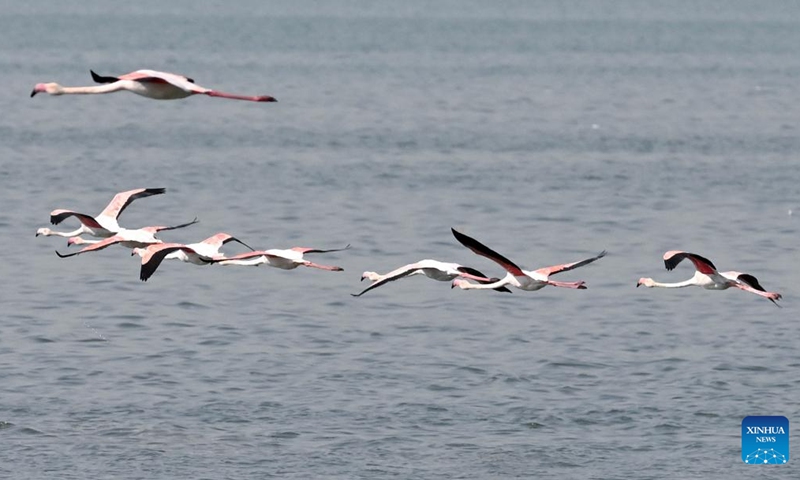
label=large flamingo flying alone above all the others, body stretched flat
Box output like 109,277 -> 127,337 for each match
31,70 -> 277,102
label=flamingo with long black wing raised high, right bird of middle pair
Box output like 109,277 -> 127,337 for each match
451,229 -> 606,291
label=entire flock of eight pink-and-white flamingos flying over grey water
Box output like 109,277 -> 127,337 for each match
30,70 -> 781,305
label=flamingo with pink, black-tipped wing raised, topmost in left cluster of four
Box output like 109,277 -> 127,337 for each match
36,188 -> 167,238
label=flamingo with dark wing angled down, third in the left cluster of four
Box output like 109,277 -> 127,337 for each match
131,232 -> 253,282
